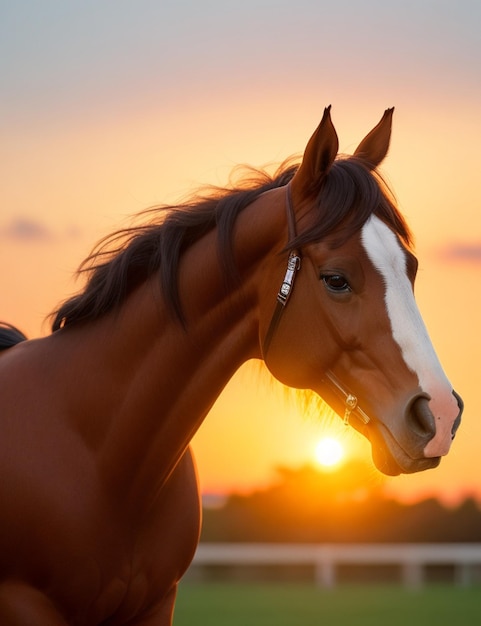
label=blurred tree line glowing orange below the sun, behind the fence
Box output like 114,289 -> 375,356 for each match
201,461 -> 481,543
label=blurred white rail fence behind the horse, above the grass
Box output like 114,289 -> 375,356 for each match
188,543 -> 481,587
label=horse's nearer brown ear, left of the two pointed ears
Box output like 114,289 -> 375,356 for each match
292,106 -> 339,202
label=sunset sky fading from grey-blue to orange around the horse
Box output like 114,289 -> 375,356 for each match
0,0 -> 481,501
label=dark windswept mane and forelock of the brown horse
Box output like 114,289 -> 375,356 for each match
51,157 -> 411,331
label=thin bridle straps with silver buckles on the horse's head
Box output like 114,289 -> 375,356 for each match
263,183 -> 371,426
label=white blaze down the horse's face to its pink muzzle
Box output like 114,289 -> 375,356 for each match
361,216 -> 459,457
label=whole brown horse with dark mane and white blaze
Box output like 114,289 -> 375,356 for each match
0,107 -> 463,626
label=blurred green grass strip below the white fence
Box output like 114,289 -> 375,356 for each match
174,582 -> 481,626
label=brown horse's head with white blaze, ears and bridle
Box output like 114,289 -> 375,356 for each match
263,107 -> 463,475
